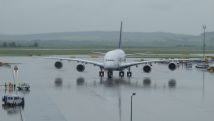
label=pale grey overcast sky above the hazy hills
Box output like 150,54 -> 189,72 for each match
0,0 -> 214,35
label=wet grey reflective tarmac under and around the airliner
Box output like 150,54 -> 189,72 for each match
0,56 -> 214,121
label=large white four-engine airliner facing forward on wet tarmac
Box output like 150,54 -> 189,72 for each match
48,22 -> 199,78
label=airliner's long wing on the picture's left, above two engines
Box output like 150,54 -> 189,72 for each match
46,57 -> 104,68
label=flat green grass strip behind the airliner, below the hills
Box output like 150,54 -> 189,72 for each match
0,48 -> 214,58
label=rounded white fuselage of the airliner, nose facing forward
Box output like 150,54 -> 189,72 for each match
104,49 -> 126,71
